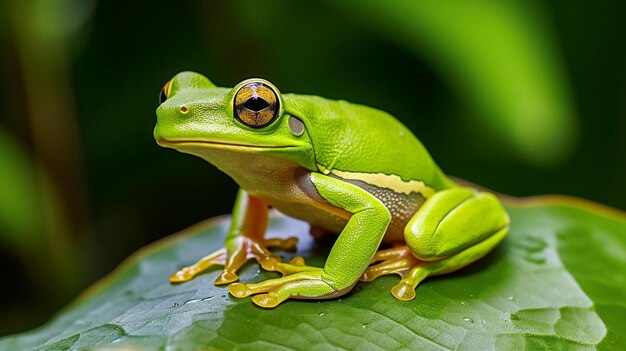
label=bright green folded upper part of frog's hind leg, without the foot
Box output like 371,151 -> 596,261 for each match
404,188 -> 509,273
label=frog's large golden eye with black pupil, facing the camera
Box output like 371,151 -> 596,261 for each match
233,82 -> 280,128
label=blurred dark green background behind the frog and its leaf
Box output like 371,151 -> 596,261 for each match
0,0 -> 626,335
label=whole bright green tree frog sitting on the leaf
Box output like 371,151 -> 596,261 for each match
154,72 -> 509,308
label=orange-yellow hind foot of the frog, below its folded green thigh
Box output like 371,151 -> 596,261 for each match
360,245 -> 430,301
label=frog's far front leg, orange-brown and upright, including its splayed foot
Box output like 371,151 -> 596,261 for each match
170,189 -> 298,285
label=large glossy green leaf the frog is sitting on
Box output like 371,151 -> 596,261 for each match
0,198 -> 626,350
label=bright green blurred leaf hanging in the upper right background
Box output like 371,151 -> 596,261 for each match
337,0 -> 578,167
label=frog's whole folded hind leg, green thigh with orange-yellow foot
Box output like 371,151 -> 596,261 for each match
361,188 -> 509,301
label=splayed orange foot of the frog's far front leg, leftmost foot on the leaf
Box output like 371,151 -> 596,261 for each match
170,236 -> 299,285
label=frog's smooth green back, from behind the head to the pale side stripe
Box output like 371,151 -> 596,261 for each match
284,94 -> 449,190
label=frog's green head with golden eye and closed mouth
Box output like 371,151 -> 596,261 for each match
154,72 -> 315,169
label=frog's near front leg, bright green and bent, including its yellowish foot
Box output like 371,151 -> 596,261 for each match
228,173 -> 391,308
